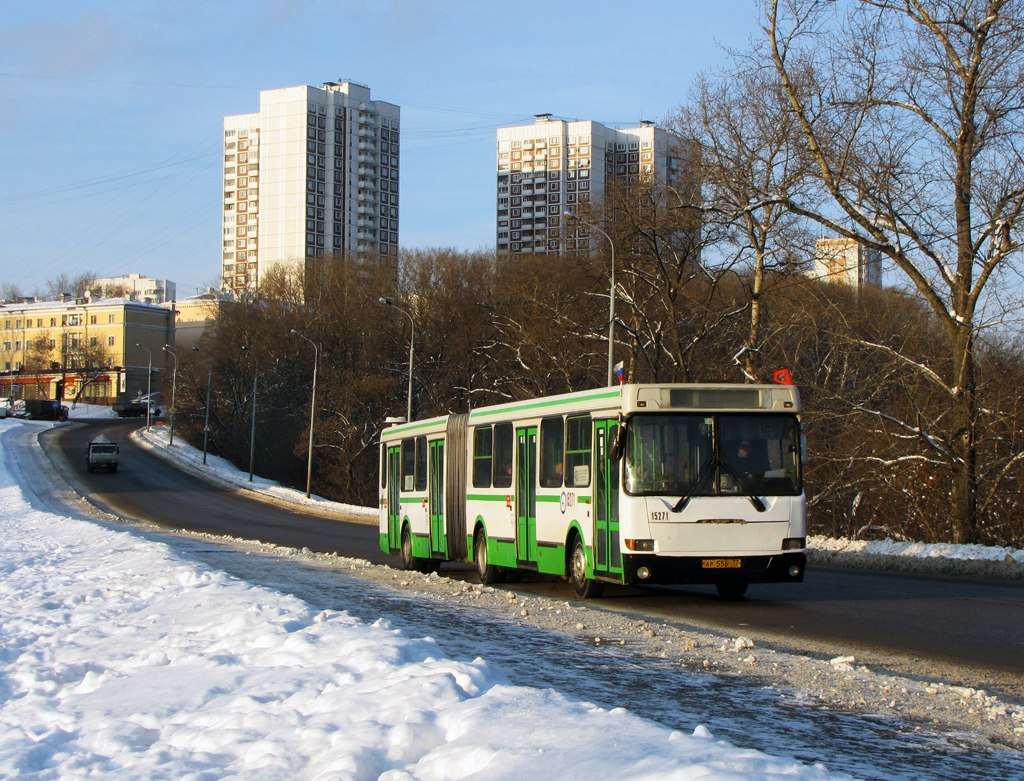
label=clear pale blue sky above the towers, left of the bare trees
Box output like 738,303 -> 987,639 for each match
0,0 -> 759,297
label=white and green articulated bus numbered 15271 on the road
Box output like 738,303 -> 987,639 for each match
380,384 -> 807,599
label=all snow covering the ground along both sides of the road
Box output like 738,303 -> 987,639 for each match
0,410 -> 1024,779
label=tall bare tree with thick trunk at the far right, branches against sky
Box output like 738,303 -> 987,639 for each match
765,0 -> 1024,543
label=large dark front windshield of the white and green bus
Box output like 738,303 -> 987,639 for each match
625,413 -> 803,496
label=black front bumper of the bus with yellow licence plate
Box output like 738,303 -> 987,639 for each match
623,551 -> 807,585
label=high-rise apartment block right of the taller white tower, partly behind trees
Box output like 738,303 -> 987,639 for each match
497,114 -> 685,255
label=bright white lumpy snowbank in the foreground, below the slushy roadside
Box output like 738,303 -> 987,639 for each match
0,429 -> 845,781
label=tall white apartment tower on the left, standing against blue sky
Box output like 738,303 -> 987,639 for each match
221,81 -> 400,293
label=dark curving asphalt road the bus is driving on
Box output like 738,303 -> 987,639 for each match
32,420 -> 1024,701
